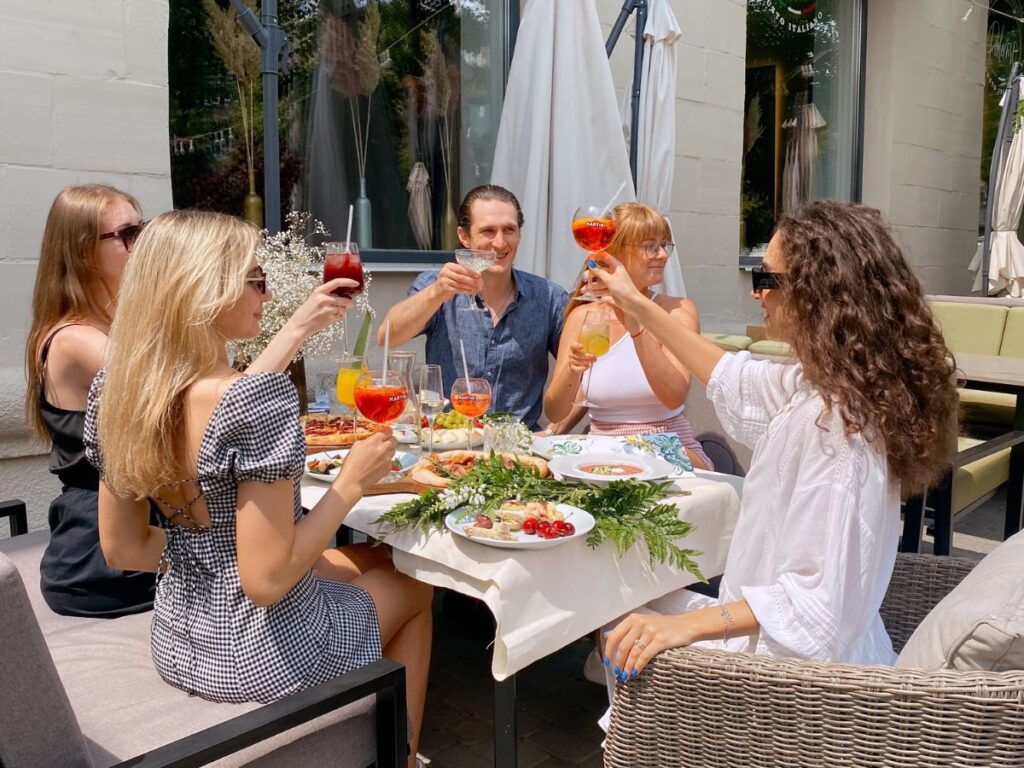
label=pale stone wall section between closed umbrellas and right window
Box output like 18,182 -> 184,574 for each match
597,0 -> 761,331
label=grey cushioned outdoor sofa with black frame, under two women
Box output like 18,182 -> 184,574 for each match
0,504 -> 408,768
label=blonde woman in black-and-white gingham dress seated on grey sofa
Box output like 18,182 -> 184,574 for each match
85,211 -> 431,765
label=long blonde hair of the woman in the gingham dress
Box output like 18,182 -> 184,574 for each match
96,211 -> 259,499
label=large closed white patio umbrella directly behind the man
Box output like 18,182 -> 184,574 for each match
490,0 -> 635,288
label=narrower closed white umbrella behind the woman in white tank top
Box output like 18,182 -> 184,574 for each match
620,0 -> 686,296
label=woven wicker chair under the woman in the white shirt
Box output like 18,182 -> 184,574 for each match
604,555 -> 1024,768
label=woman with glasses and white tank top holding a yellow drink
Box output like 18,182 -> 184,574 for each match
544,203 -> 714,469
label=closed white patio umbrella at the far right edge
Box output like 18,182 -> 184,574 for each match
969,90 -> 1024,298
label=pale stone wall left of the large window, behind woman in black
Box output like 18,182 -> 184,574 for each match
0,0 -> 171,536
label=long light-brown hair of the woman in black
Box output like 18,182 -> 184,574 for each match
25,184 -> 141,440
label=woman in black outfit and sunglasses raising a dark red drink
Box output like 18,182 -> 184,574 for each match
26,184 -> 350,617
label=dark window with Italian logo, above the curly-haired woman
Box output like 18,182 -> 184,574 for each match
740,0 -> 860,250
